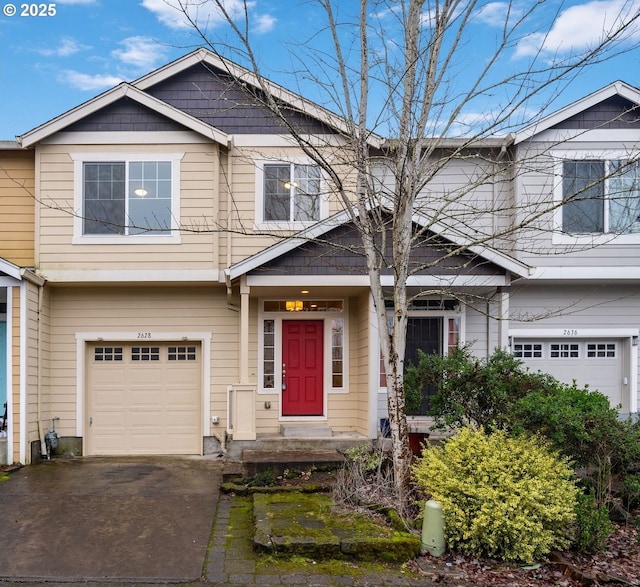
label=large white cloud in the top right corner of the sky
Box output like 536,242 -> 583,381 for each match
515,0 -> 640,57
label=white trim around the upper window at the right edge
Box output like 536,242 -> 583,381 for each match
550,149 -> 640,247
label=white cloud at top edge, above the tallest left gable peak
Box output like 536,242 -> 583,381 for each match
142,0 -> 255,29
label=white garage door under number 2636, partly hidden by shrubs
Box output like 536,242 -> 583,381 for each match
513,339 -> 623,406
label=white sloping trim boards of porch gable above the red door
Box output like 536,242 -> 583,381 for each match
226,210 -> 532,280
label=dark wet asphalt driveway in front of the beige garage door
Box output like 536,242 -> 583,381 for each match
0,457 -> 222,582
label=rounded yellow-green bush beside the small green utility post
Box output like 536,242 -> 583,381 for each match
413,428 -> 578,563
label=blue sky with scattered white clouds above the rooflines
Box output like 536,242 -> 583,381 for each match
0,0 -> 640,140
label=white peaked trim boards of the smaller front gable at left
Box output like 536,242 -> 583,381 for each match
18,82 -> 229,147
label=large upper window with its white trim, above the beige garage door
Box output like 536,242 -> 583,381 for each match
72,153 -> 183,244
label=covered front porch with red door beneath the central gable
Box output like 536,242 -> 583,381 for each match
220,215 -> 524,458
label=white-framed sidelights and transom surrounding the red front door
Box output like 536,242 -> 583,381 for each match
258,299 -> 348,393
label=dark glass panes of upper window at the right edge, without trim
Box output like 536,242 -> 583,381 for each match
562,159 -> 640,234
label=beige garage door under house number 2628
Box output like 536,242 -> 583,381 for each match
85,342 -> 202,455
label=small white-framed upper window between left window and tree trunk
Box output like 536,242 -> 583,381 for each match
256,160 -> 327,228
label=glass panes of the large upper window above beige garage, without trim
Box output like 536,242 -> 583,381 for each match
82,161 -> 172,236
